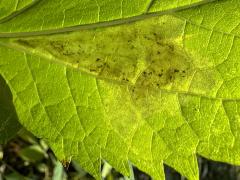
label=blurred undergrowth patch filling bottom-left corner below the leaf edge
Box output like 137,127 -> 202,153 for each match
0,129 -> 86,180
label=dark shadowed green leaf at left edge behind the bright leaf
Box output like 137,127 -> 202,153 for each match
0,75 -> 21,144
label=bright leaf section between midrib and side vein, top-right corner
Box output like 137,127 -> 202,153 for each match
174,0 -> 240,35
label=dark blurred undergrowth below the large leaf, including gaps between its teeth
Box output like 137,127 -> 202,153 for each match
0,130 -> 240,180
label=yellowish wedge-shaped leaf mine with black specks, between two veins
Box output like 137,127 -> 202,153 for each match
11,18 -> 194,91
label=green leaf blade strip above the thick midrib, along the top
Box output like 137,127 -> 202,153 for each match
0,0 -> 213,33
